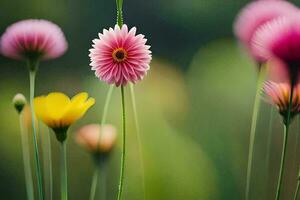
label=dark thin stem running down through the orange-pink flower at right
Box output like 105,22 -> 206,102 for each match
275,83 -> 294,200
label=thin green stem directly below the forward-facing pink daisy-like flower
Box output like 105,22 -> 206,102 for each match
117,86 -> 126,200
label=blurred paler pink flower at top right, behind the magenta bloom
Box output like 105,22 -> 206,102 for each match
234,0 -> 298,62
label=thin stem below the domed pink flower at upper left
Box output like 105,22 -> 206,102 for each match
29,70 -> 44,199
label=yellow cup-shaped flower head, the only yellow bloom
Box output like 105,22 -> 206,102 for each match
34,92 -> 95,141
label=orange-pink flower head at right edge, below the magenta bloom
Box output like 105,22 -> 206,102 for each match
264,81 -> 300,122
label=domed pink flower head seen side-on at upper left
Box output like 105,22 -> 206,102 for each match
0,19 -> 68,60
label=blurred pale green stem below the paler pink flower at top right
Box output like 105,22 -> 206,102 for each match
245,67 -> 266,200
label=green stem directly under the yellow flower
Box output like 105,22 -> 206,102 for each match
60,141 -> 68,200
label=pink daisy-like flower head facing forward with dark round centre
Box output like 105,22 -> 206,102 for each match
89,25 -> 152,86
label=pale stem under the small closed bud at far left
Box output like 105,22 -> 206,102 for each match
19,114 -> 34,200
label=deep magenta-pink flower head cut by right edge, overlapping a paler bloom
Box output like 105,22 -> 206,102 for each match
253,12 -> 300,84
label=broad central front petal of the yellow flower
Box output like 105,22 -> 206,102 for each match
46,92 -> 70,121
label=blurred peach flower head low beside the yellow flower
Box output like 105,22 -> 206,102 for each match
76,124 -> 117,154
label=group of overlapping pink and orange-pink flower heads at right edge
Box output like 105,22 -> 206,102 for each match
235,0 -> 300,119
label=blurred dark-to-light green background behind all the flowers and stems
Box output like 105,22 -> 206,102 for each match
0,0 -> 300,200
